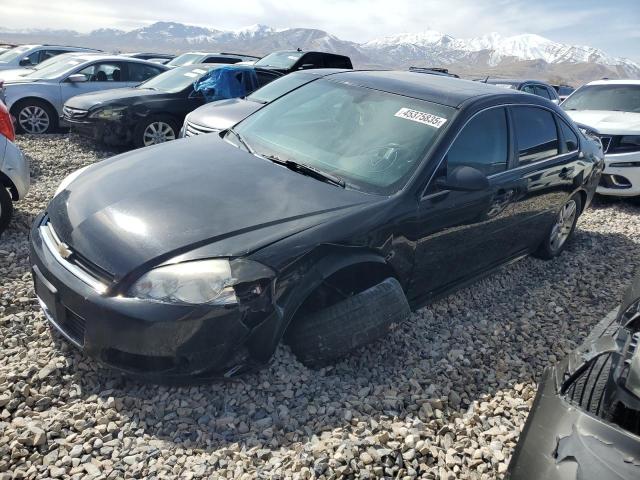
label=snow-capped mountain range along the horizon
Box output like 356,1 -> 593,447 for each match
0,22 -> 640,84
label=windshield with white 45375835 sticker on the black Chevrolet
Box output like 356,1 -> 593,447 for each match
232,79 -> 454,195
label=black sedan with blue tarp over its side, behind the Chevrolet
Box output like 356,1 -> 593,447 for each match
63,64 -> 280,147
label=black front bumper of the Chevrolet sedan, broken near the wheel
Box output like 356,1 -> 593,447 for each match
30,212 -> 278,383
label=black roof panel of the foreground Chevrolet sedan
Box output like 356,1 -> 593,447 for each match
331,70 -> 526,108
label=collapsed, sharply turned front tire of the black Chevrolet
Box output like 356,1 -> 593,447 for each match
285,278 -> 411,367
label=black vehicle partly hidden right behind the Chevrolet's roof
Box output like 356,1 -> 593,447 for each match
255,49 -> 353,74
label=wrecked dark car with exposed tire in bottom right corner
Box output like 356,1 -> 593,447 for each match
509,277 -> 640,480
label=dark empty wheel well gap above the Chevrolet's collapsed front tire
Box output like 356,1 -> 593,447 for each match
291,262 -> 397,323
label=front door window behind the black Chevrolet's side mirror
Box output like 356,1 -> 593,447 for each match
447,108 -> 509,175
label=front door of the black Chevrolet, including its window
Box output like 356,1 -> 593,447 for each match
409,107 -> 519,300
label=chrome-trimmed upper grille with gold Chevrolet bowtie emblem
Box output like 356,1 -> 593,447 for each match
40,219 -> 113,293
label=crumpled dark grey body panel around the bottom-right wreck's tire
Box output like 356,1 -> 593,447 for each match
506,326 -> 640,480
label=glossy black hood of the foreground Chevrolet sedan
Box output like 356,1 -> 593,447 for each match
47,135 -> 379,278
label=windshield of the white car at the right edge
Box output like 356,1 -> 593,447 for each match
562,85 -> 640,113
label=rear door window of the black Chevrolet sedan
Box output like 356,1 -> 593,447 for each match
512,107 -> 558,165
